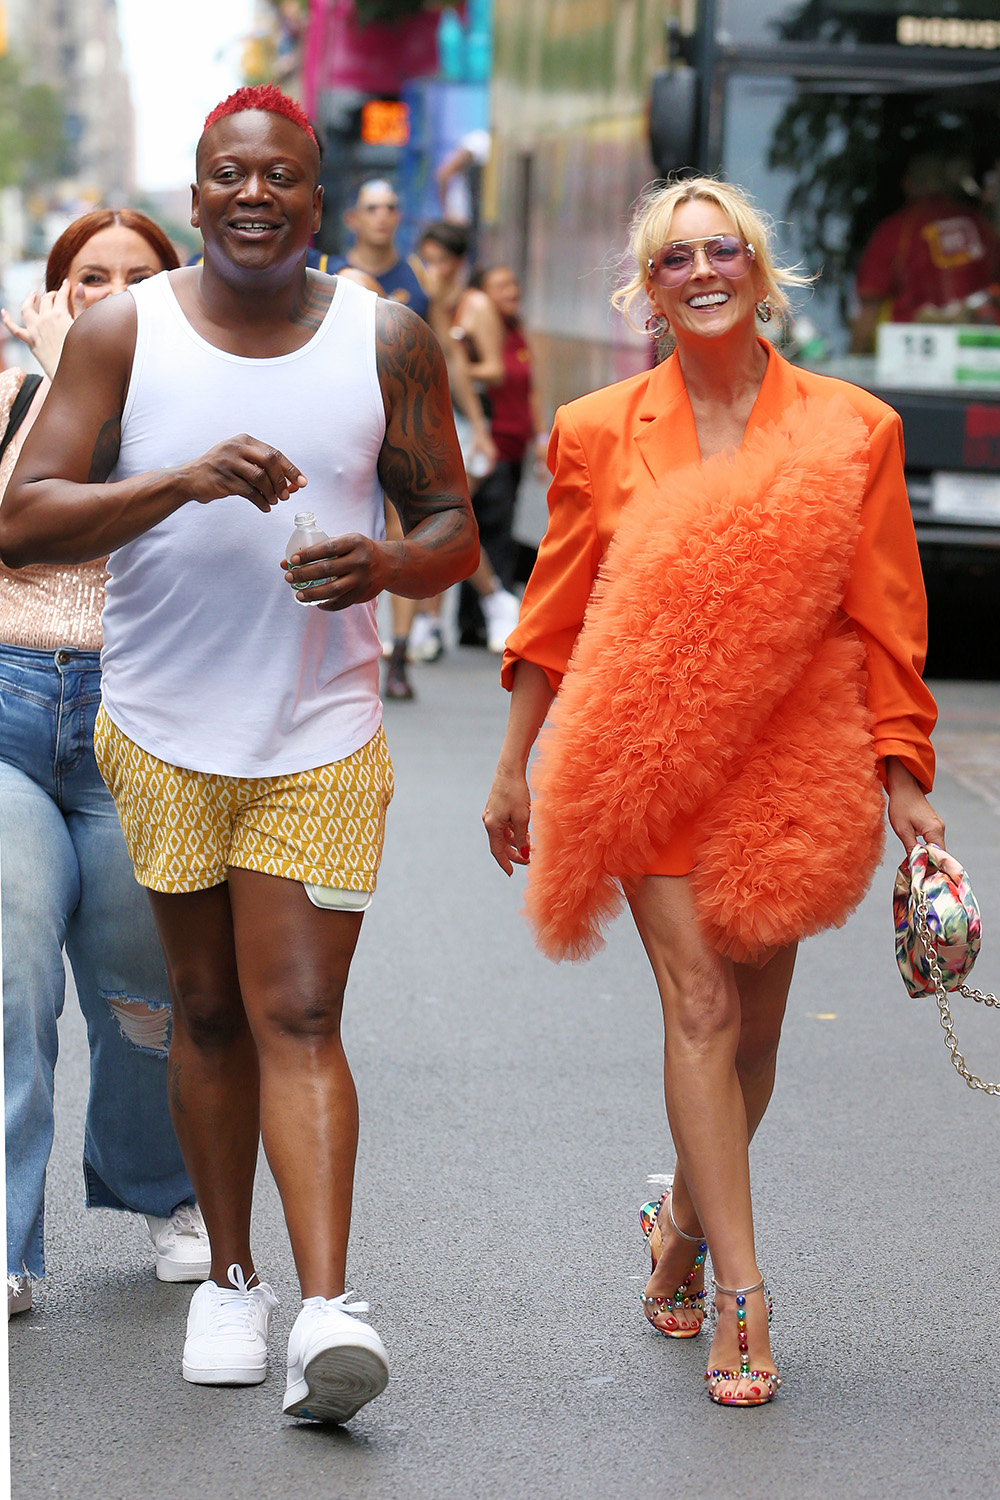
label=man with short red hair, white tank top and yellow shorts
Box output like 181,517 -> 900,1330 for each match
0,87 -> 478,1422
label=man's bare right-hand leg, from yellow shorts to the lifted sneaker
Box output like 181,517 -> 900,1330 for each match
229,870 -> 361,1298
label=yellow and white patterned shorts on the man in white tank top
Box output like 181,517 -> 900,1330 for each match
94,708 -> 393,893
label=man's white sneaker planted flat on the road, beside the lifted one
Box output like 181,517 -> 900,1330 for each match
181,1266 -> 277,1386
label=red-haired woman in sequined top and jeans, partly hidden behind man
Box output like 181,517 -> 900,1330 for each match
0,209 -> 210,1313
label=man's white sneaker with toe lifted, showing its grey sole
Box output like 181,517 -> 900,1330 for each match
282,1292 -> 388,1422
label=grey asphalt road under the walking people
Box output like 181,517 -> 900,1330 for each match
9,666 -> 1000,1500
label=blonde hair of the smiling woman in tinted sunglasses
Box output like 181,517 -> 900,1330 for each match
612,177 -> 816,329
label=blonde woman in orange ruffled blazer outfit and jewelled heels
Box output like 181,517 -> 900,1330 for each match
484,177 -> 943,1406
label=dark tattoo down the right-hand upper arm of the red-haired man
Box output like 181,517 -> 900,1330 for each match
376,299 -> 465,546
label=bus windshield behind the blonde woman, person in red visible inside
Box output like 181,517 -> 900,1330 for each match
723,71 -> 1000,384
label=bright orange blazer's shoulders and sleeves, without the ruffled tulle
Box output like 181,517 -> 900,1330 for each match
501,341 -> 937,792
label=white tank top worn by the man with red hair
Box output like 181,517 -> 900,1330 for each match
100,273 -> 385,777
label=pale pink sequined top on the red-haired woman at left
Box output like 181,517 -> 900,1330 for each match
0,369 -> 108,651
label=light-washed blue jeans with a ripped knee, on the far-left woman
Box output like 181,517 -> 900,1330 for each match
0,645 -> 193,1277
